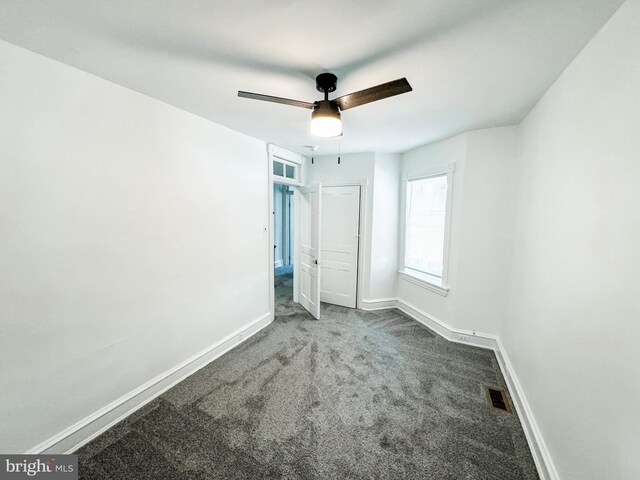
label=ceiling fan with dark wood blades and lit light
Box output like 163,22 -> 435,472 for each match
238,73 -> 413,137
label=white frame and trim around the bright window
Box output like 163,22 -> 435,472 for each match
398,163 -> 455,296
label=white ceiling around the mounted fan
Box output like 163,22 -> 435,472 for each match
0,0 -> 622,154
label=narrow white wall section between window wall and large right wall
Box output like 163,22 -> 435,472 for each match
454,127 -> 517,334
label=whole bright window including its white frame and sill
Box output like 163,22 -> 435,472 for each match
400,168 -> 452,295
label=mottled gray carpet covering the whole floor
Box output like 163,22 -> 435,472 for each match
77,274 -> 538,480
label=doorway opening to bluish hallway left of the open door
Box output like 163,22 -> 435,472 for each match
273,183 -> 295,316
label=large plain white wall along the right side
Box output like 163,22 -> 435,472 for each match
501,0 -> 640,480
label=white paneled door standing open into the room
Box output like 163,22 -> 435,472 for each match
298,183 -> 322,319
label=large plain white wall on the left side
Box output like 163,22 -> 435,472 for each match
0,42 -> 272,453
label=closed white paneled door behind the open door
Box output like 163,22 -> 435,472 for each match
320,186 -> 360,308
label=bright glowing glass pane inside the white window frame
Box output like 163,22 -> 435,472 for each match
405,175 -> 447,278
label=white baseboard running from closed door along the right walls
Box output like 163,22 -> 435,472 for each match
362,298 -> 559,480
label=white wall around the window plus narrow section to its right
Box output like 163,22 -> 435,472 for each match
397,127 -> 517,334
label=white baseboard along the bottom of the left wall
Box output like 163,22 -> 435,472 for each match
26,312 -> 273,454
